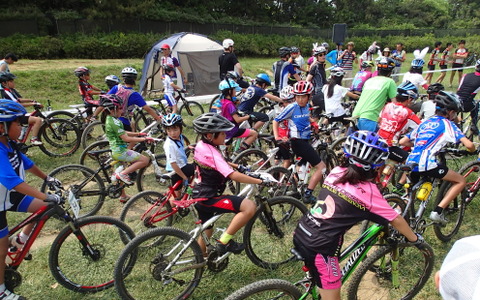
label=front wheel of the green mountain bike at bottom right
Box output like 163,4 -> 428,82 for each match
347,244 -> 434,300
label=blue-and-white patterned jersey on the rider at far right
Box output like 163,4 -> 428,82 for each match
406,116 -> 465,172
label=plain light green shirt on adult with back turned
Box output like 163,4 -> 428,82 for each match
353,76 -> 397,122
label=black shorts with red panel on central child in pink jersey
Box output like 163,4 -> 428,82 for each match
195,195 -> 245,223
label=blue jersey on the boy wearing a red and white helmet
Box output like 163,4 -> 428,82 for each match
275,102 -> 311,140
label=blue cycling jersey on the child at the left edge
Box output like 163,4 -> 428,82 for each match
0,142 -> 34,211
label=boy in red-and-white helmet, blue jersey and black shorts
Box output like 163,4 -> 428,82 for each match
272,81 -> 325,203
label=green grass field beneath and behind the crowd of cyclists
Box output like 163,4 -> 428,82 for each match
5,58 -> 480,300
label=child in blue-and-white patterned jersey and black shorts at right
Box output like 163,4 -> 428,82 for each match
400,91 -> 475,225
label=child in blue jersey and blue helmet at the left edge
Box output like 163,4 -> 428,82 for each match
0,99 -> 61,300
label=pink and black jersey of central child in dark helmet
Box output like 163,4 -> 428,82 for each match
192,141 -> 234,198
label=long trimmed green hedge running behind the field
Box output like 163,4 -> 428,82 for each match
0,31 -> 480,59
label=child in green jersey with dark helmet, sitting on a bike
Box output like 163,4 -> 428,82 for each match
101,95 -> 153,202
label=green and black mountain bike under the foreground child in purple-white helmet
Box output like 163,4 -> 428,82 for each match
225,224 -> 434,300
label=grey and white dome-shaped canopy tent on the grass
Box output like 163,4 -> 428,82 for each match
140,32 -> 223,95
